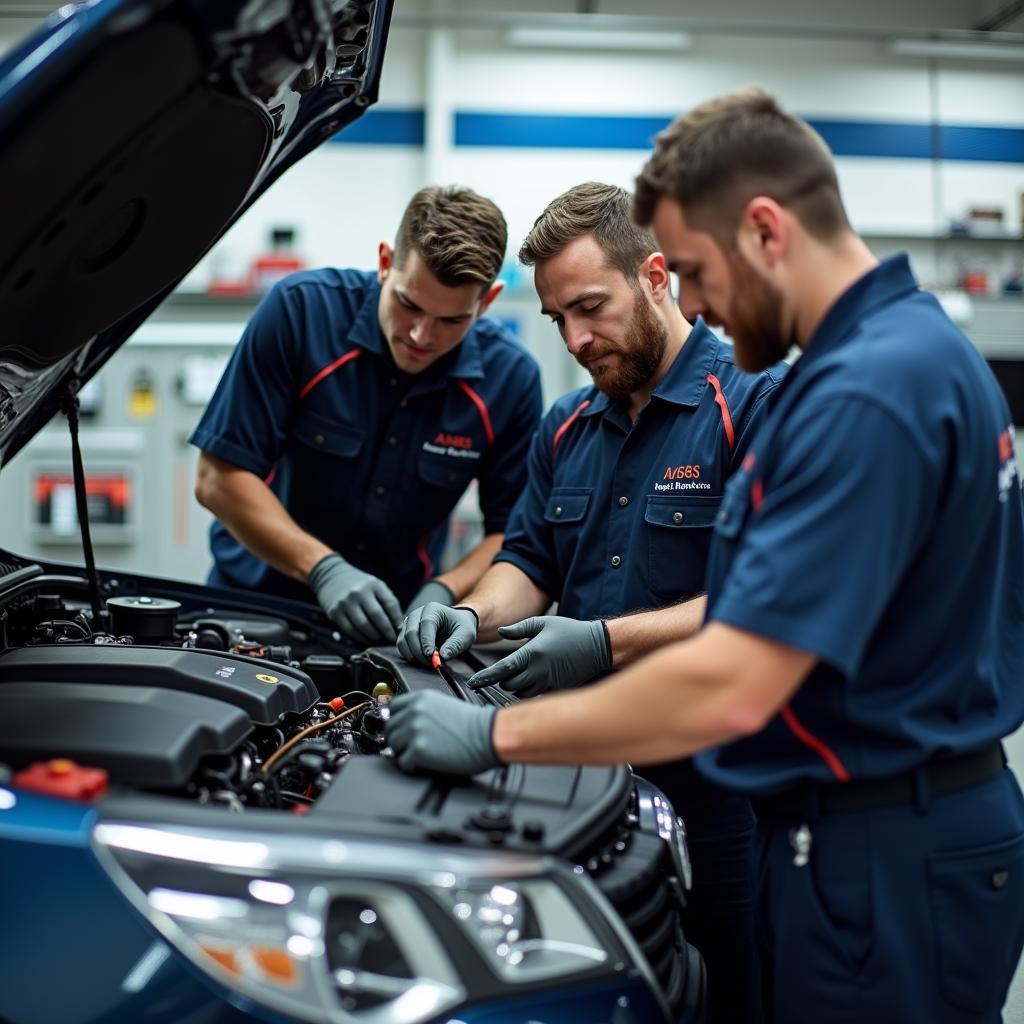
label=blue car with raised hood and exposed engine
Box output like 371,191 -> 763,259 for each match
0,0 -> 705,1024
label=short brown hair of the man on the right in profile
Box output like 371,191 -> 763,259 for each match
633,88 -> 850,247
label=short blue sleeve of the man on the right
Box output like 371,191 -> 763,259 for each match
709,393 -> 939,678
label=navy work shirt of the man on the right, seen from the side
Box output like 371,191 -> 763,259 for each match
697,256 -> 1024,793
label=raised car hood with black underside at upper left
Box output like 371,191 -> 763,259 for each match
0,0 -> 393,464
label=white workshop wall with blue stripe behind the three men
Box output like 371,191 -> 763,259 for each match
193,29 -> 1024,287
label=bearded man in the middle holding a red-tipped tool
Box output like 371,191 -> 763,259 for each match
398,182 -> 784,1022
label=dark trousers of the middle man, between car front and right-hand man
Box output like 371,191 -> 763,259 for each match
637,760 -> 763,1024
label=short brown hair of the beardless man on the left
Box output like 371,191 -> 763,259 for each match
394,185 -> 509,288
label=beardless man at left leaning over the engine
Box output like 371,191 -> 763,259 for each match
191,186 -> 541,643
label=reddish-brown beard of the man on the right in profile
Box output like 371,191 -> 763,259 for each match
716,250 -> 797,373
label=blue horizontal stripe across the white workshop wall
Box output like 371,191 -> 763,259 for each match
330,109 -> 1024,164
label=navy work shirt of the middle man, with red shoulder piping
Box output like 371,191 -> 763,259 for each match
495,319 -> 785,618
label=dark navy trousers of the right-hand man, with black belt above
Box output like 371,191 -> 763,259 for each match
755,769 -> 1024,1024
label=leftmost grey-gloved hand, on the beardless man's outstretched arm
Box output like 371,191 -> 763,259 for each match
309,553 -> 401,643
